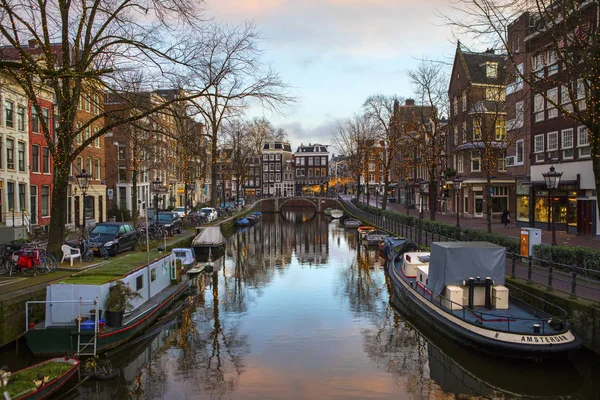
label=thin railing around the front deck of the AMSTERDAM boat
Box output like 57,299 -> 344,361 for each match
416,283 -> 568,335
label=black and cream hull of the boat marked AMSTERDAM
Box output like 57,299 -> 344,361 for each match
387,261 -> 581,359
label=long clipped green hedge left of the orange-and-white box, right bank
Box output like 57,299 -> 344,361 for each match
352,199 -> 519,253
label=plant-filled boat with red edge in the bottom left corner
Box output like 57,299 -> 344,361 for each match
0,358 -> 80,400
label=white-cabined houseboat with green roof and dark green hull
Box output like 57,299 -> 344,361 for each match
25,253 -> 189,357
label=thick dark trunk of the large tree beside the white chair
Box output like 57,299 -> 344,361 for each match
48,166 -> 70,258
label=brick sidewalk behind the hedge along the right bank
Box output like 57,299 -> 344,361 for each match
343,195 -> 600,249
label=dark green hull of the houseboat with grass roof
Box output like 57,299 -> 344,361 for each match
25,280 -> 190,357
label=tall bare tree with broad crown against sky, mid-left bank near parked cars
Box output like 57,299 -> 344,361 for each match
190,24 -> 294,205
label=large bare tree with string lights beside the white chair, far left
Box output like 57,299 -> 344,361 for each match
0,0 -> 211,252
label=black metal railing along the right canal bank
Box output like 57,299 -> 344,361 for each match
338,197 -> 600,301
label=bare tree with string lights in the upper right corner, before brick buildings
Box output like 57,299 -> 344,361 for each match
445,0 -> 600,225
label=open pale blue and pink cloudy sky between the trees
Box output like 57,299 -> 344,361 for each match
207,0 -> 456,152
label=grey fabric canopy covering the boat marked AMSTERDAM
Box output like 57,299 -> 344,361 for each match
427,242 -> 506,293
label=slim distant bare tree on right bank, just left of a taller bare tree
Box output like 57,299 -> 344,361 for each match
363,94 -> 401,210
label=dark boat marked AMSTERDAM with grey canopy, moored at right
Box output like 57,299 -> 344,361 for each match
388,242 -> 581,358
